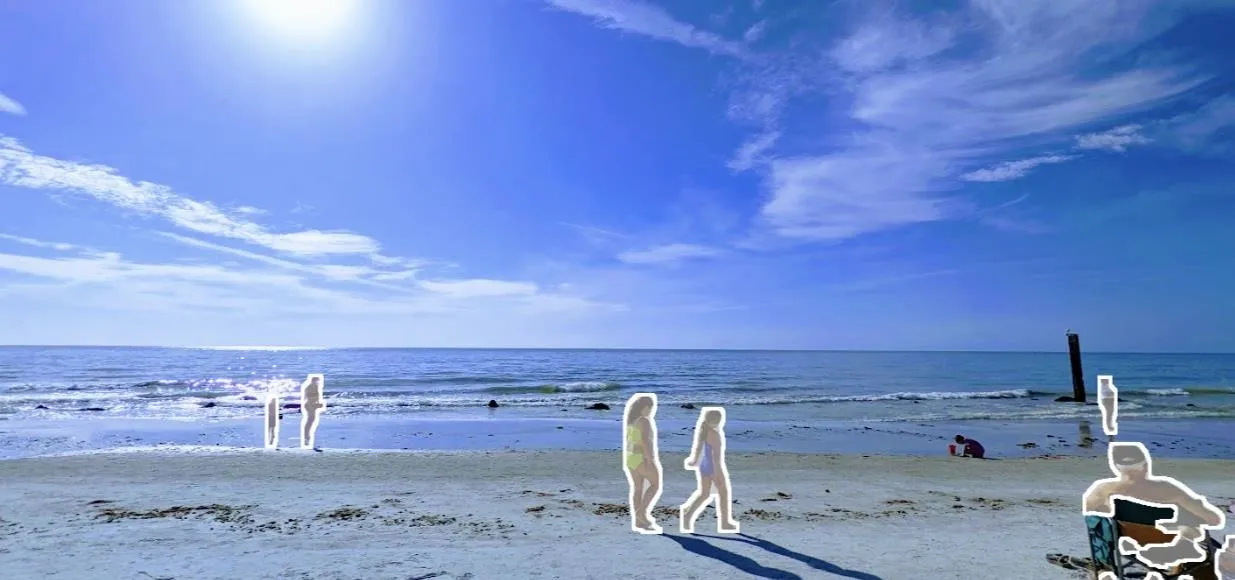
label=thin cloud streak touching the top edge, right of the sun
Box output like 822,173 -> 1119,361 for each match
545,0 -> 746,57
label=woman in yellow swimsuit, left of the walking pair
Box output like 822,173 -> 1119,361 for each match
622,392 -> 662,533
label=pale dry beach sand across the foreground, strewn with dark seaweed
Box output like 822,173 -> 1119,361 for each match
0,448 -> 1235,580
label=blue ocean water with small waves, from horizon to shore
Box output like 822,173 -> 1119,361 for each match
0,347 -> 1235,457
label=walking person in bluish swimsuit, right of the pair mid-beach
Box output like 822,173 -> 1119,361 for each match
679,407 -> 741,533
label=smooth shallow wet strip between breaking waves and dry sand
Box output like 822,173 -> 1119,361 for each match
0,411 -> 1235,459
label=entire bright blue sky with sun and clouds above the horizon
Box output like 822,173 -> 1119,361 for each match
0,0 -> 1235,352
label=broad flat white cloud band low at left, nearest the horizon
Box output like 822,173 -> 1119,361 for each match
0,234 -> 621,316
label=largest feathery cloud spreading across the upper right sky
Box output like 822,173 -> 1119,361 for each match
763,0 -> 1204,239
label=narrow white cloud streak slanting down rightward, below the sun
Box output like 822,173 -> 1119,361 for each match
0,136 -> 380,255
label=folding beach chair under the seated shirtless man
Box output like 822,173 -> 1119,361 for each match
1084,500 -> 1221,580
